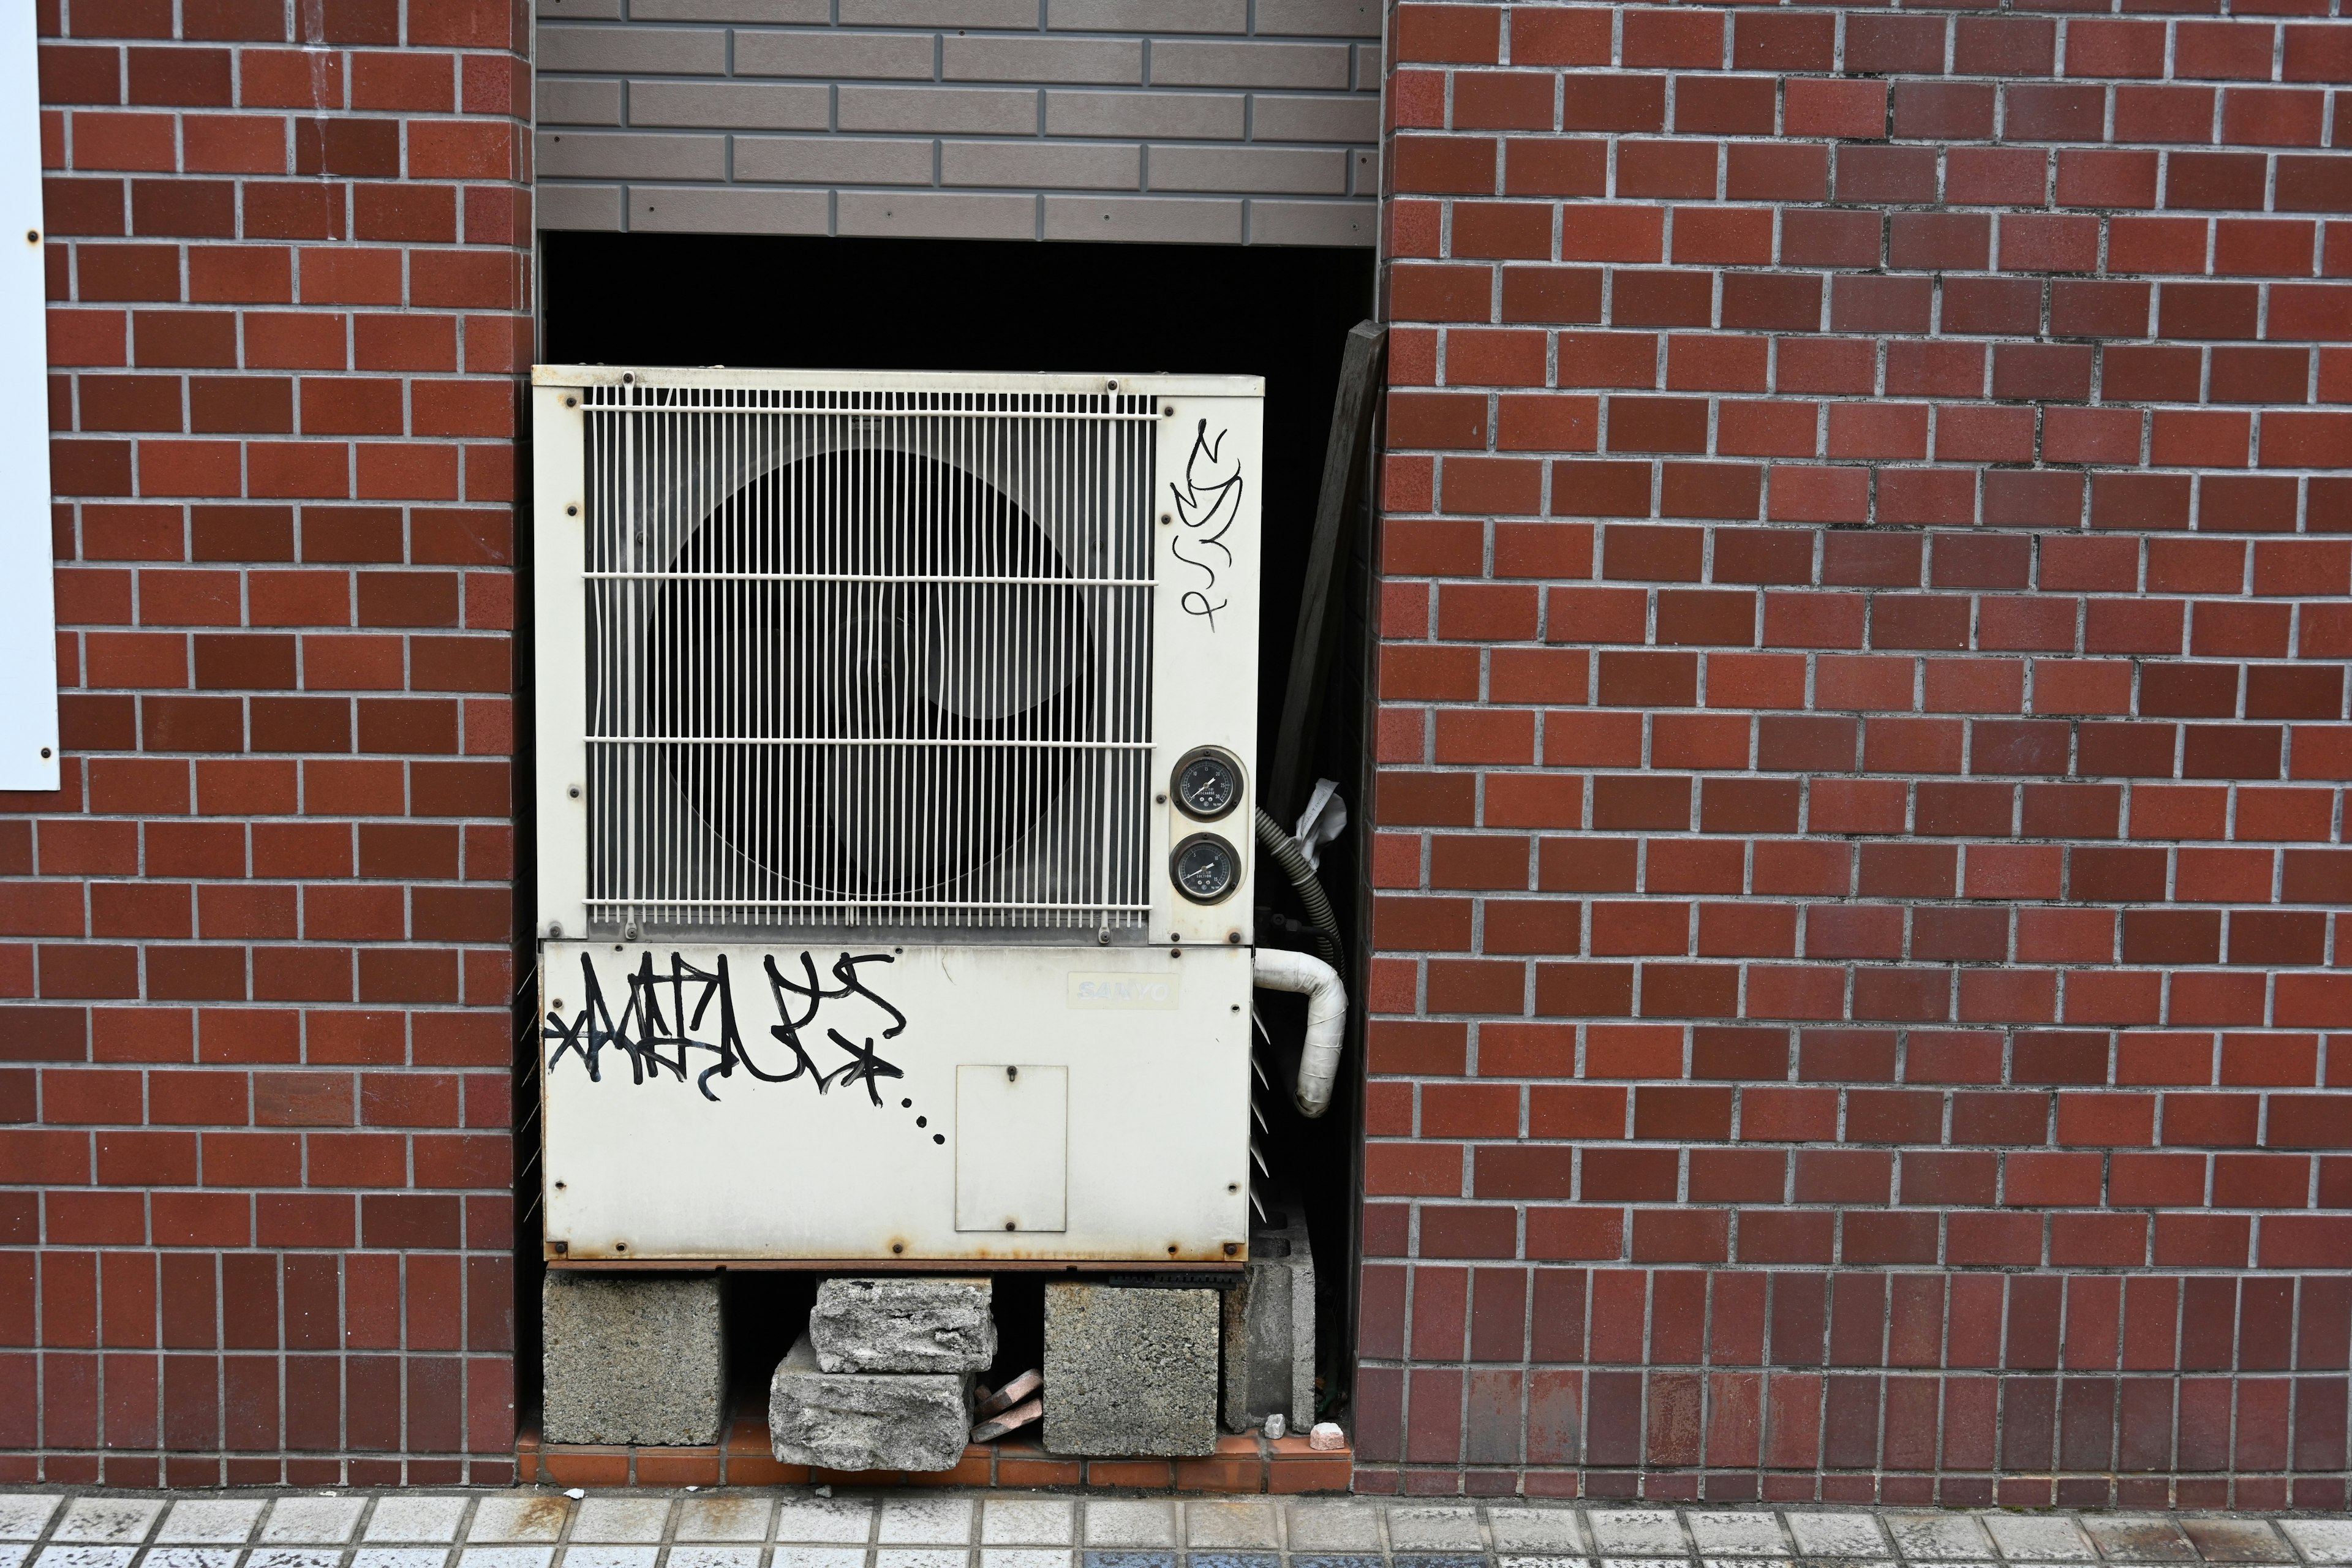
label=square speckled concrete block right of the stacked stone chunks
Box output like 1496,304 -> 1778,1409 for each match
1044,1284 -> 1218,1455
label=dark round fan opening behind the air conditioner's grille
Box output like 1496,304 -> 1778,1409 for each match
639,447 -> 1098,900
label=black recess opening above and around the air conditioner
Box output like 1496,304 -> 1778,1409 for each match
533,233 -> 1374,1438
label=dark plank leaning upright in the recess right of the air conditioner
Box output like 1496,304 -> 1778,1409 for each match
1258,322 -> 1388,830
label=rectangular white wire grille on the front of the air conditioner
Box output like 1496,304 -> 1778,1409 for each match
573,388 -> 1157,933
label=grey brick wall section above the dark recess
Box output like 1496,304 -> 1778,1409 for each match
537,0 -> 1383,247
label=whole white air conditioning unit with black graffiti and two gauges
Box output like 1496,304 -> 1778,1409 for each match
532,367 -> 1263,1267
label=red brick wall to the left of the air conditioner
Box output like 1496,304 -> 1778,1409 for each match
0,0 -> 529,1486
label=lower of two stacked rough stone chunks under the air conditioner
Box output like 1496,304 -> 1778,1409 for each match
767,1335 -> 971,1469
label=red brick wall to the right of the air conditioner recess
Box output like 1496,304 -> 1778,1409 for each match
1357,0 -> 2352,1507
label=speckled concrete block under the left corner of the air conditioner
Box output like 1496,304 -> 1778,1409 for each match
538,1270 -> 727,1448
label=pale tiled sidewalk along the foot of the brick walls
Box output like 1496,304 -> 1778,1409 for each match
0,1488 -> 2352,1568
